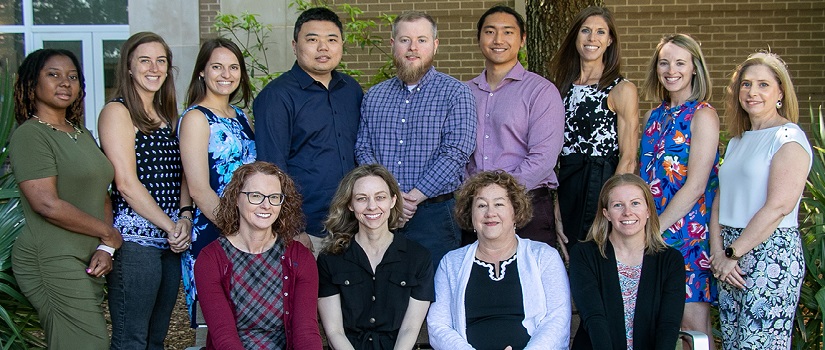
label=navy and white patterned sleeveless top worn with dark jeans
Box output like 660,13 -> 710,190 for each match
112,115 -> 183,249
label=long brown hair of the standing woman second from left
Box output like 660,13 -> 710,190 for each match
112,32 -> 178,135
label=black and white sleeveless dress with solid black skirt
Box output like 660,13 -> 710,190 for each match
557,77 -> 625,249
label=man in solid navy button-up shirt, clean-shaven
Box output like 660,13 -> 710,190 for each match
253,8 -> 364,254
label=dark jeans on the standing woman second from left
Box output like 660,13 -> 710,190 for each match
106,242 -> 181,350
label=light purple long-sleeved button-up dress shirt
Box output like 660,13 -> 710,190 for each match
467,63 -> 564,190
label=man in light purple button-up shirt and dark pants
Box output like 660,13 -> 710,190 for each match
467,6 -> 564,247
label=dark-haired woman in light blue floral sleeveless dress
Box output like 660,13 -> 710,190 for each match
178,38 -> 257,327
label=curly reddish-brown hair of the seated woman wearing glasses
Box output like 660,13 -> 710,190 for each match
215,161 -> 304,244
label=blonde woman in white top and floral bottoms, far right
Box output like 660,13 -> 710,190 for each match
710,52 -> 812,349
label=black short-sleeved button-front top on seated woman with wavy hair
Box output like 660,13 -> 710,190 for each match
318,234 -> 435,349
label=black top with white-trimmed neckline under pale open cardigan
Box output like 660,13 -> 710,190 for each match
464,255 -> 530,350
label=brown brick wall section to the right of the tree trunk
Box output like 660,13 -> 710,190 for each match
605,0 -> 825,124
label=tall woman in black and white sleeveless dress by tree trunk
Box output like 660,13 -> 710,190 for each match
551,6 -> 639,258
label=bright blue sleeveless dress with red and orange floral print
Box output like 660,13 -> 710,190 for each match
640,101 -> 719,303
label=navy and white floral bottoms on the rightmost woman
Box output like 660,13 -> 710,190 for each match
719,226 -> 805,350
